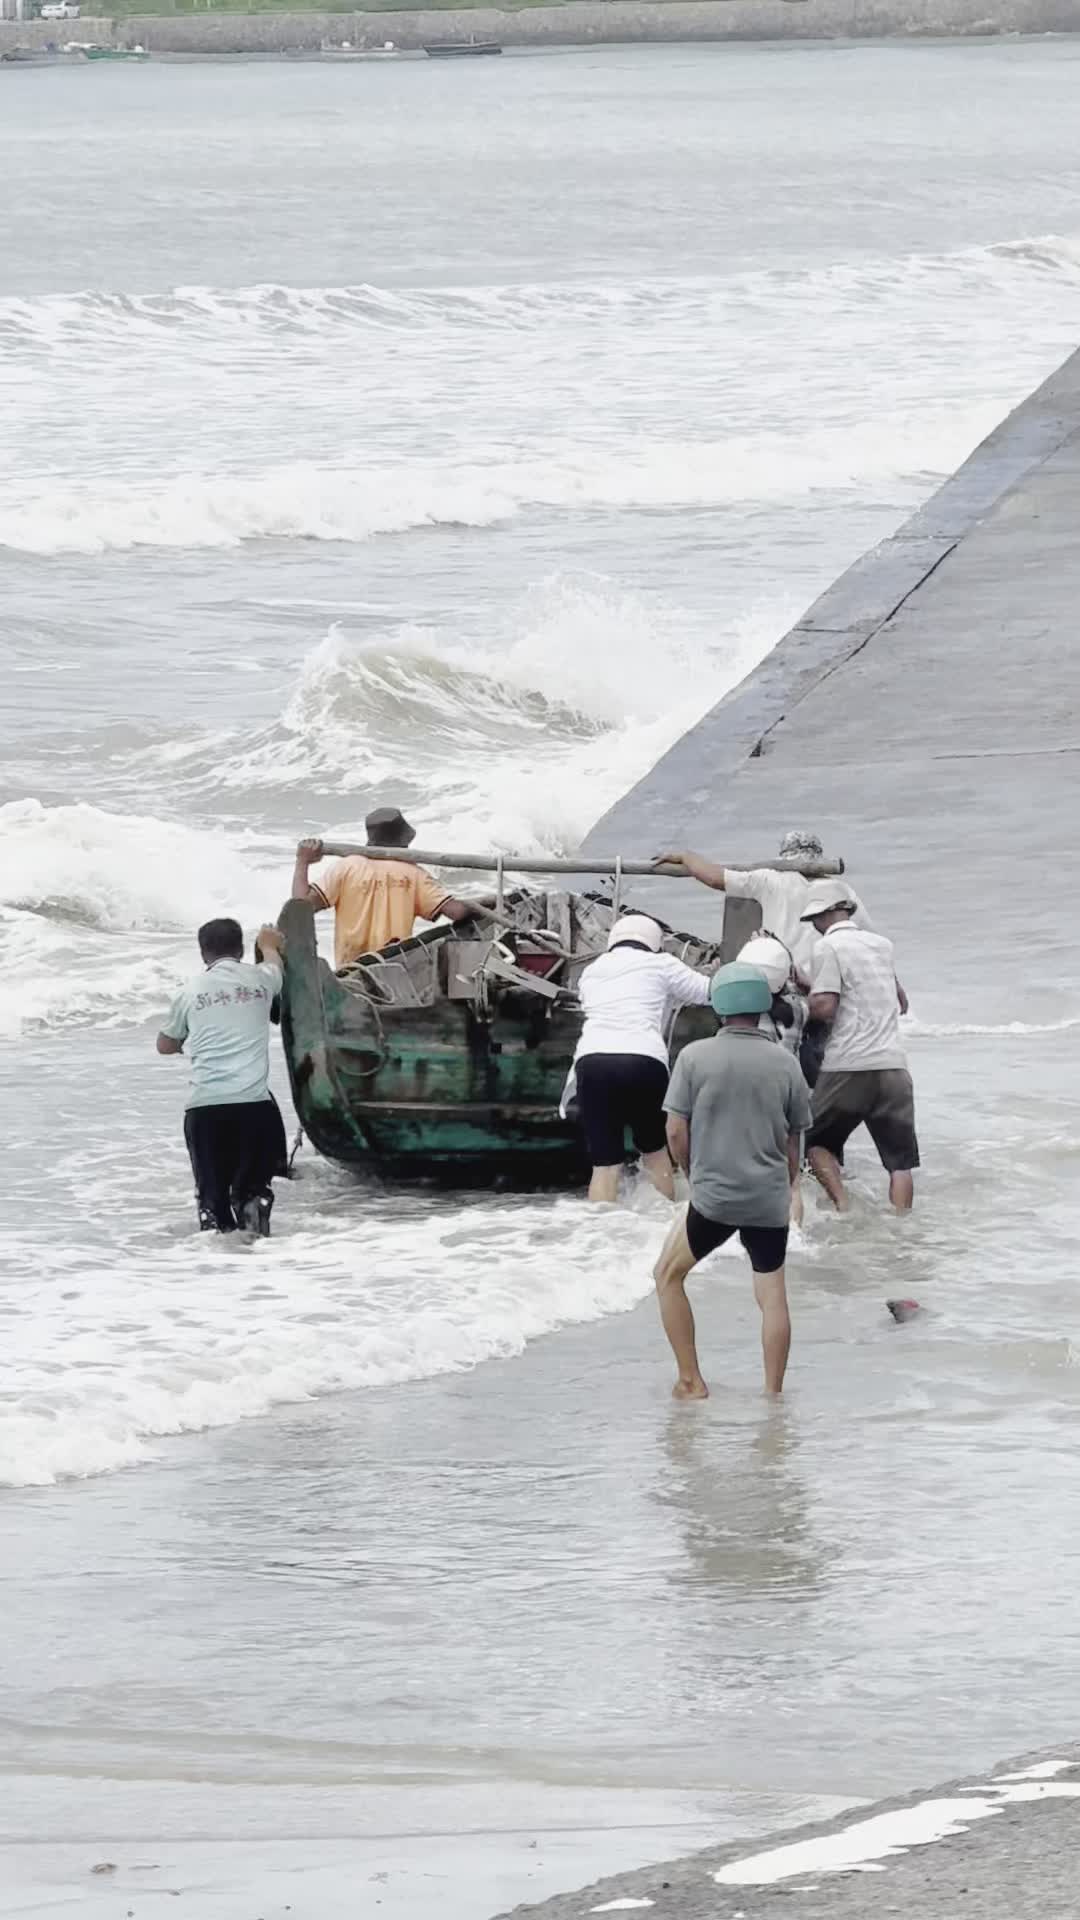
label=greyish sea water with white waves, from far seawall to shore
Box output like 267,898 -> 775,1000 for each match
0,40 -> 1080,1920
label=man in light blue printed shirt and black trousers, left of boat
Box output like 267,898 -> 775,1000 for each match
158,920 -> 282,1235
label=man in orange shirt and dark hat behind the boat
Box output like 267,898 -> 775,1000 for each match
292,806 -> 477,972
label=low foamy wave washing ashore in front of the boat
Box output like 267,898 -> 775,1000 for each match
0,1198 -> 665,1486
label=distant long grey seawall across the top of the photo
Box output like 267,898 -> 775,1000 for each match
0,0 -> 1080,58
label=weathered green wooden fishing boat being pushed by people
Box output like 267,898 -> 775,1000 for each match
272,845 -> 836,1188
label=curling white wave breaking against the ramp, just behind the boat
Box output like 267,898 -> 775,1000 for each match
119,576 -> 780,852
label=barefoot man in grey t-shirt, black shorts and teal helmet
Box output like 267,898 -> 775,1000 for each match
655,962 -> 811,1400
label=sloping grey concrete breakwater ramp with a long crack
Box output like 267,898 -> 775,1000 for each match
586,353 -> 1080,1021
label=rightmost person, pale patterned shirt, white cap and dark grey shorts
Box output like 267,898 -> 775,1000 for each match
803,879 -> 919,1213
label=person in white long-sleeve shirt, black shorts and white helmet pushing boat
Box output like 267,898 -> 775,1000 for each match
575,914 -> 709,1202
